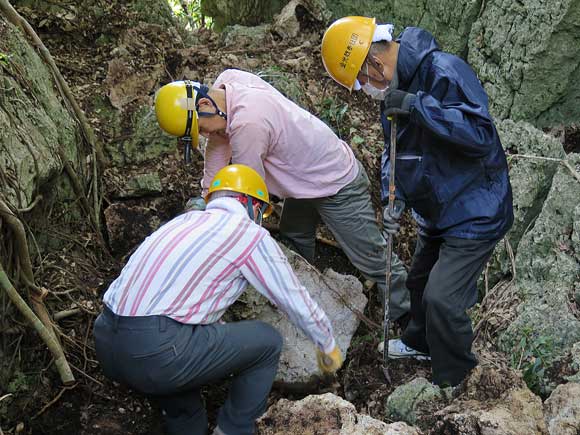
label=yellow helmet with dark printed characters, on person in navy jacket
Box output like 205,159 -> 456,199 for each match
321,17 -> 377,91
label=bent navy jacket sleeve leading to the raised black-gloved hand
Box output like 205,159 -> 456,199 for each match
411,67 -> 497,158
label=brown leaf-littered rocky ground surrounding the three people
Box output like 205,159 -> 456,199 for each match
0,0 -> 579,435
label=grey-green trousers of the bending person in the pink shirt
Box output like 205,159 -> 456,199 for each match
280,162 -> 410,319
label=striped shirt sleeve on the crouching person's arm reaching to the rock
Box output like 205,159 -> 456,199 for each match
241,236 -> 336,353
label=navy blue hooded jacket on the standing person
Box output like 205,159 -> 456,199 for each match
381,27 -> 513,240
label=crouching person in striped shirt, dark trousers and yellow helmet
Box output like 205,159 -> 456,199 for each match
94,165 -> 342,435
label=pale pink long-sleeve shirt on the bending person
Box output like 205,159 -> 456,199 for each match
202,69 -> 358,199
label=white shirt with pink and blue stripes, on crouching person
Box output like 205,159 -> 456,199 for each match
103,198 -> 335,353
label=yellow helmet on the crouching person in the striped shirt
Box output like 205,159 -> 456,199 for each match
205,165 -> 272,217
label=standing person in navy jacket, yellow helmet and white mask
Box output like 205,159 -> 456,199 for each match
322,17 -> 513,386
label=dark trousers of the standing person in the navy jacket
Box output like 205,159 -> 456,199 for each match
401,235 -> 498,385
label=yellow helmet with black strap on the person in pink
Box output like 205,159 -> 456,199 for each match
155,80 -> 199,147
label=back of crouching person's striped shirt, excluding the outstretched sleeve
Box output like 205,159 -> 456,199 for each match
103,199 -> 268,324
